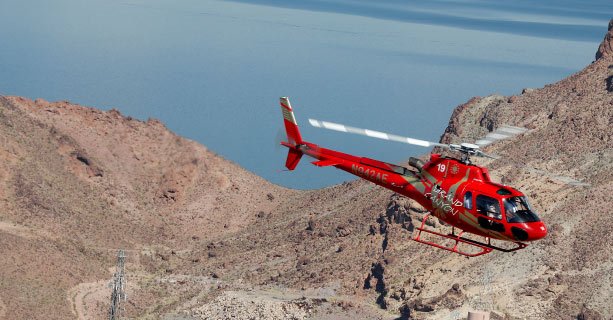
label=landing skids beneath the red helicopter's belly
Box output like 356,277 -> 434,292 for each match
413,213 -> 528,257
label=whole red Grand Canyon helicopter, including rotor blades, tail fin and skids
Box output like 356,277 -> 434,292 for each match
280,97 -> 547,257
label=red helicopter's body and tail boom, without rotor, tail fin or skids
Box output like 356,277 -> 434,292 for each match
283,142 -> 547,242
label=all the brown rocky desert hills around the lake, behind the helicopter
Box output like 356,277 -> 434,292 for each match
0,21 -> 613,319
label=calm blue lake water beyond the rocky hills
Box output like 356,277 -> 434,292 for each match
0,0 -> 613,189
